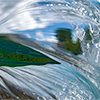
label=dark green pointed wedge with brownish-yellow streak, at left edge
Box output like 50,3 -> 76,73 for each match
0,36 -> 58,67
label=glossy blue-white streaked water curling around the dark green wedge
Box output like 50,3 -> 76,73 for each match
0,0 -> 100,100
